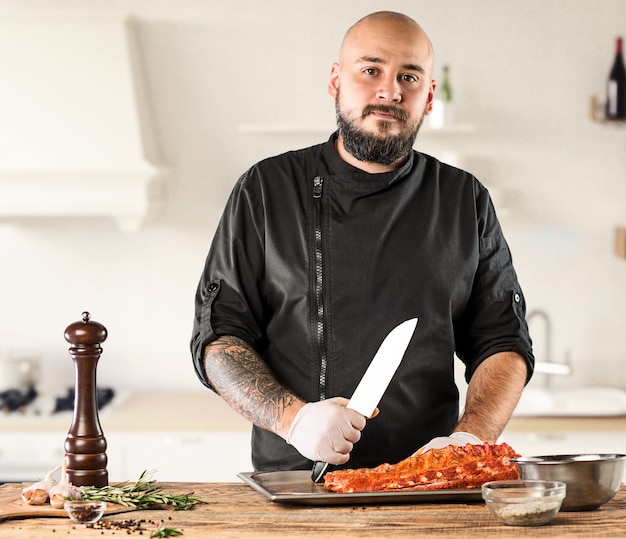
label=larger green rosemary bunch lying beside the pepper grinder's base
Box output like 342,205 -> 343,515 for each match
80,470 -> 206,511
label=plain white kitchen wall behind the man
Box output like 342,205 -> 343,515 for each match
0,0 -> 626,396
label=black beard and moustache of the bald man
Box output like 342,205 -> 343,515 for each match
335,101 -> 424,166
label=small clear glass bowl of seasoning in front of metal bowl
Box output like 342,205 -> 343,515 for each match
482,480 -> 566,526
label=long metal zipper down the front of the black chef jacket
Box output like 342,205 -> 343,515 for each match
313,176 -> 328,400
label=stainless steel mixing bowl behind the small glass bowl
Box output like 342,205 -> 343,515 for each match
511,453 -> 626,511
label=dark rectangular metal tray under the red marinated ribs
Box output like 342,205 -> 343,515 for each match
237,470 -> 482,505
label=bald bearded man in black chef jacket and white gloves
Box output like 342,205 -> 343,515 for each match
191,12 -> 534,470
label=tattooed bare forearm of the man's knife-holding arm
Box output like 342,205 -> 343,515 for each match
204,336 -> 298,435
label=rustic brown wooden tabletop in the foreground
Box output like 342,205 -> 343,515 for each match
0,483 -> 626,539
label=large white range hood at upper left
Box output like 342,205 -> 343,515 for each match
0,7 -> 165,230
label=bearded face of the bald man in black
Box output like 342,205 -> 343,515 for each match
329,16 -> 436,165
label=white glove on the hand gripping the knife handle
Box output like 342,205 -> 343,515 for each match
287,397 -> 365,464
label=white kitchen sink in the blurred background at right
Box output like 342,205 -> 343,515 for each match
513,387 -> 626,417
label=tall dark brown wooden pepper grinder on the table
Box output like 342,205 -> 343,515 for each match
65,312 -> 109,487
